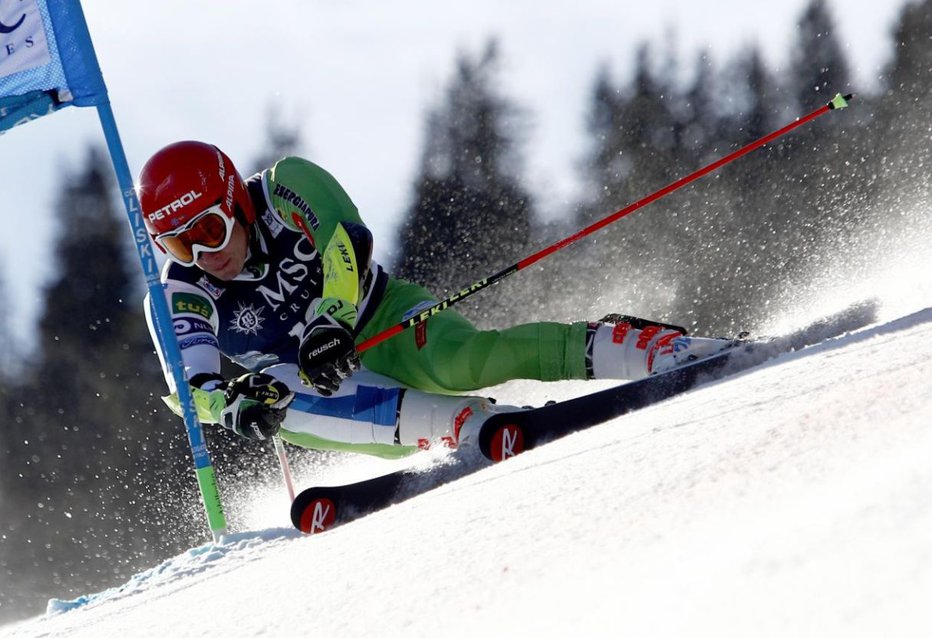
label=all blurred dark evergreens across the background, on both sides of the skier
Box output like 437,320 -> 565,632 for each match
0,0 -> 932,620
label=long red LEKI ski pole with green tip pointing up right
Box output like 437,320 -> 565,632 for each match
356,93 -> 854,352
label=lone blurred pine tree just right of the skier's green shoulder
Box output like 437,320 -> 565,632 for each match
394,41 -> 533,322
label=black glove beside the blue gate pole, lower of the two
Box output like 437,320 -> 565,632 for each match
217,372 -> 294,441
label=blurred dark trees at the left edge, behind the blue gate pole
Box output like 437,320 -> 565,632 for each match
0,150 -> 193,624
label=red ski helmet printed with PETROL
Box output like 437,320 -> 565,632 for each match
136,141 -> 256,258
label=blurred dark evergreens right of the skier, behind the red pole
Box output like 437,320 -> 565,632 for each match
396,0 -> 930,335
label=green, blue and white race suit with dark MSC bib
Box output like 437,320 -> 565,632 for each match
146,157 -> 591,457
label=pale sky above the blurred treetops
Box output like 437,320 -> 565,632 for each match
0,0 -> 904,350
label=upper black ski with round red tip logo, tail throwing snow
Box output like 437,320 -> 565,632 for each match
476,303 -> 876,462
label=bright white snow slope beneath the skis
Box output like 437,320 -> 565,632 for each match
0,309 -> 932,638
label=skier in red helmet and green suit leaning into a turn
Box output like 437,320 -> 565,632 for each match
137,141 -> 733,458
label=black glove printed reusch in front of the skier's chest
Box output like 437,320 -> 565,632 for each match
298,314 -> 359,397
